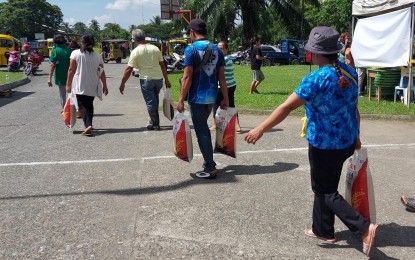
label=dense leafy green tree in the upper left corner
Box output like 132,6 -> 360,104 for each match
0,0 -> 63,40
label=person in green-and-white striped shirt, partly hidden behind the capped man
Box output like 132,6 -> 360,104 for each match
210,41 -> 241,133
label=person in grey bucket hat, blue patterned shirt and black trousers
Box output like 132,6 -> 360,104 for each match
245,26 -> 377,256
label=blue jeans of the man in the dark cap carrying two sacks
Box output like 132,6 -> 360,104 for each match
189,103 -> 216,170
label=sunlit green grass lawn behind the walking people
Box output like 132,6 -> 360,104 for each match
169,64 -> 415,115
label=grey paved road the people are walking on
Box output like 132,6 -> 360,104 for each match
0,61 -> 415,259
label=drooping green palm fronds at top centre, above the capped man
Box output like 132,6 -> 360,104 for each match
181,0 -> 319,46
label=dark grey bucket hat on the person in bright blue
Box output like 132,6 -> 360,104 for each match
304,26 -> 342,54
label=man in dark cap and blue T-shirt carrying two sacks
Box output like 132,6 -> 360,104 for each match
177,19 -> 229,179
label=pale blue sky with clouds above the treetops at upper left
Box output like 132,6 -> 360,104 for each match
0,0 -> 166,29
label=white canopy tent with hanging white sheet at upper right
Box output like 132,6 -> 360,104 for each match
352,0 -> 415,107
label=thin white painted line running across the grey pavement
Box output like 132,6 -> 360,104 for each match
0,143 -> 415,167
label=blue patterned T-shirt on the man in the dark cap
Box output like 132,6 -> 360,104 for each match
184,40 -> 225,104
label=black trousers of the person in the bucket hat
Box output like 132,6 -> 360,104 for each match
308,144 -> 370,238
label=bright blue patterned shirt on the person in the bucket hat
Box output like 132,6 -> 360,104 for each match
295,62 -> 359,149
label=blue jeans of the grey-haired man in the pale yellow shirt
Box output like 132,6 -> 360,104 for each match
140,79 -> 163,111
